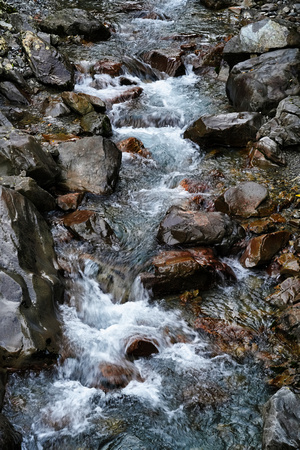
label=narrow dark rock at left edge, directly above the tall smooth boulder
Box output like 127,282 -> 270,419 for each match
0,176 -> 56,212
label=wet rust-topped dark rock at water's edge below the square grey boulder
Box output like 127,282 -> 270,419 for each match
63,210 -> 114,243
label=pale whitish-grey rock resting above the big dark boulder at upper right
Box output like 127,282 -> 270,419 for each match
223,18 -> 300,67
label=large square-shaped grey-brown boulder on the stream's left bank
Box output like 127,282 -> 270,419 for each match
58,136 -> 121,194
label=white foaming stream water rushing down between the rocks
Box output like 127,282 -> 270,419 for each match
5,0 -> 284,450
